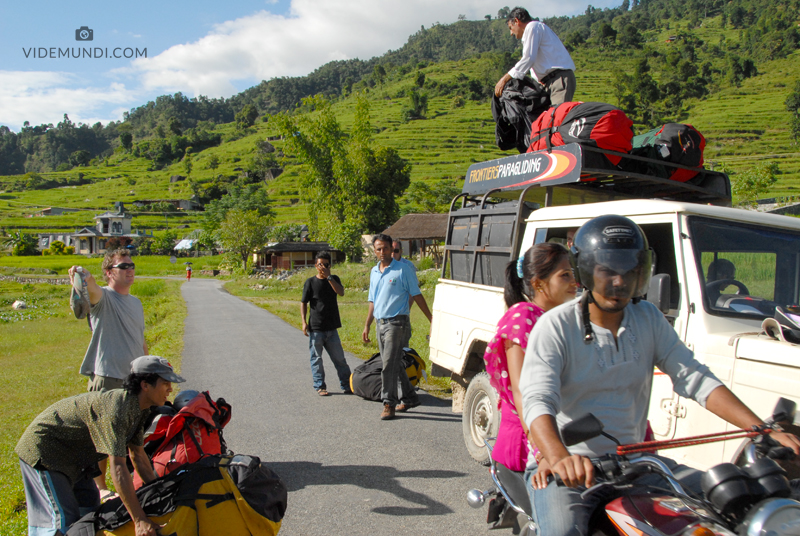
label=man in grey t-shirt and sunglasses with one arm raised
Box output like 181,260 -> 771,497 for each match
69,249 -> 149,499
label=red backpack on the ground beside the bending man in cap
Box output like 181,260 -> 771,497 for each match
133,391 -> 231,489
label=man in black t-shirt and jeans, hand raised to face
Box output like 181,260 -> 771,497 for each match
300,251 -> 351,396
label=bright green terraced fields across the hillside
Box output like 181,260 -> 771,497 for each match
0,13 -> 800,239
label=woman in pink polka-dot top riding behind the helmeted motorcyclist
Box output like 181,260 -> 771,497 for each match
483,243 -> 577,478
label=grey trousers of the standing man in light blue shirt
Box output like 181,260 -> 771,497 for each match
378,315 -> 419,407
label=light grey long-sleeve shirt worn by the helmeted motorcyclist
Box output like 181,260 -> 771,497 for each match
520,298 -> 722,457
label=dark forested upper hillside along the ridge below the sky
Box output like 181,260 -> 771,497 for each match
0,0 -> 800,175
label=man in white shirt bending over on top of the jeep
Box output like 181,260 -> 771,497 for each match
494,7 -> 575,106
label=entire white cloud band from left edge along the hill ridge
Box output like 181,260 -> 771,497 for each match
0,0 -> 619,128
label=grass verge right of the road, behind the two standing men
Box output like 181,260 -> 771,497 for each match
225,263 -> 450,395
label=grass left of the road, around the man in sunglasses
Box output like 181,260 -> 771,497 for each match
0,278 -> 186,536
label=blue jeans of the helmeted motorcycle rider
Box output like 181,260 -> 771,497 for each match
525,456 -> 703,536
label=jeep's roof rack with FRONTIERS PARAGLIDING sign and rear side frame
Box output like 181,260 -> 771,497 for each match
442,143 -> 731,287
